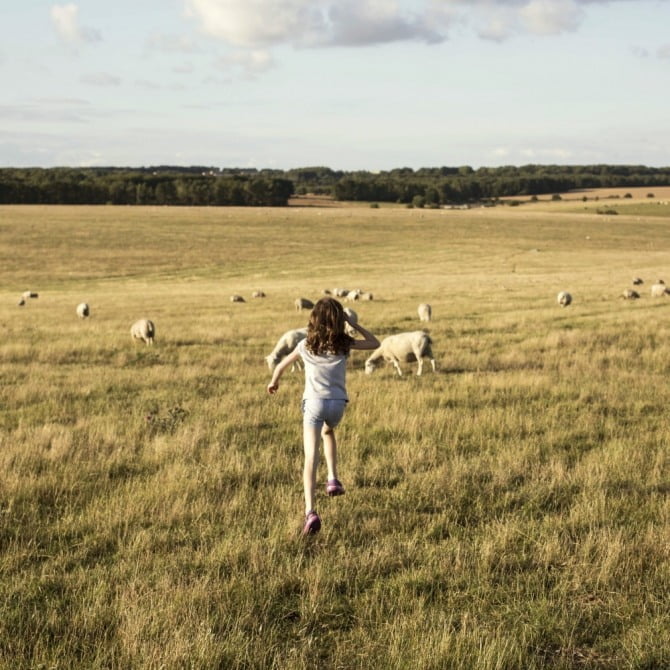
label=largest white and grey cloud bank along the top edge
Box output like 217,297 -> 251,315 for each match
182,0 -> 616,49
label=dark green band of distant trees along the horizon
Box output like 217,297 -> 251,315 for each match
0,165 -> 670,207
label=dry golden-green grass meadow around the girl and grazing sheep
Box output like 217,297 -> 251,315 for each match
0,199 -> 670,670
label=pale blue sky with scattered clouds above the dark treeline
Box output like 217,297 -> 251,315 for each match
0,0 -> 670,171
